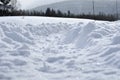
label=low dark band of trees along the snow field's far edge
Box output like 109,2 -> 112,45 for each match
0,8 -> 117,21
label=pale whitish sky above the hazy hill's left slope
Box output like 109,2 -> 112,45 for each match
19,0 -> 65,9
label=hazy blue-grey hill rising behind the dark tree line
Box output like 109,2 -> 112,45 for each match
34,0 -> 120,14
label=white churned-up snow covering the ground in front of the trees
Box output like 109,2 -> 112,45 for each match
0,17 -> 120,80
